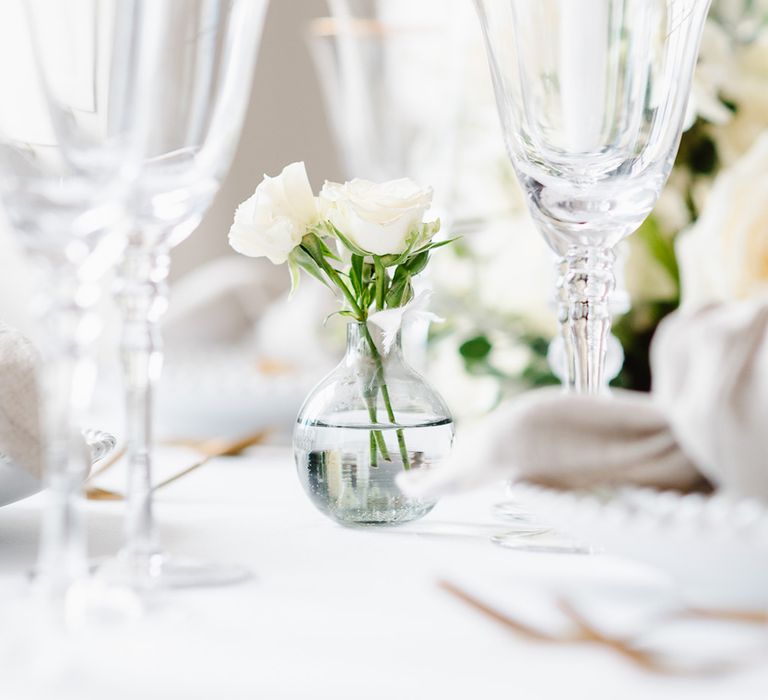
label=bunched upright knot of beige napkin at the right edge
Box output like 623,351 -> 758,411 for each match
651,296 -> 768,500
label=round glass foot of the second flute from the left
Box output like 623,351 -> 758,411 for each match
96,553 -> 253,590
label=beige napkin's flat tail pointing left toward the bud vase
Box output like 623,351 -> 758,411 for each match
399,387 -> 701,495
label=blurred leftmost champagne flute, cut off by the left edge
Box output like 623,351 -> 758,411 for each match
0,0 -> 157,598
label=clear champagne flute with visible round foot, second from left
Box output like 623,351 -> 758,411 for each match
103,0 -> 267,589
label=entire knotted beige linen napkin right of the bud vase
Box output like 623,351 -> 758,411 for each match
400,299 -> 768,500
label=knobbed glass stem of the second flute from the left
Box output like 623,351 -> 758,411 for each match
119,243 -> 170,567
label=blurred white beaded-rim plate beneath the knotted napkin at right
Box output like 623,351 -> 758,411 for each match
513,484 -> 768,609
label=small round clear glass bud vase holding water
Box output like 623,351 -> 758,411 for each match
293,323 -> 454,526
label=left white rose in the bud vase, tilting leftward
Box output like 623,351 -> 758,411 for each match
229,163 -> 320,265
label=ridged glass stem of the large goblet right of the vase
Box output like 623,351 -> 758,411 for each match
559,247 -> 616,394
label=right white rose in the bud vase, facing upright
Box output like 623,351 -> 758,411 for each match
320,178 -> 432,255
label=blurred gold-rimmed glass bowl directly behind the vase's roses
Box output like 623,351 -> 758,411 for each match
309,0 -> 464,191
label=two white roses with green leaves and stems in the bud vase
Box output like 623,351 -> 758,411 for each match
229,163 -> 451,469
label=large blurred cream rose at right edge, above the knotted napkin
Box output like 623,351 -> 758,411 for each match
677,132 -> 768,307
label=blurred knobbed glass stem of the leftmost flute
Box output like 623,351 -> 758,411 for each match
35,269 -> 100,596
